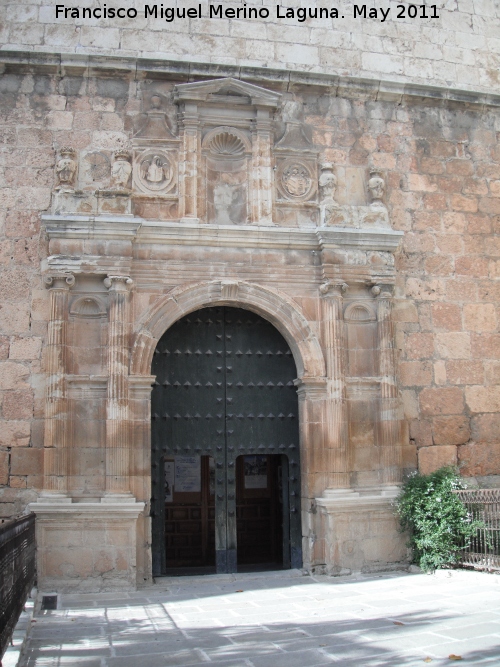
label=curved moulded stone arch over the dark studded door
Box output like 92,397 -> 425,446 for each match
130,280 -> 326,379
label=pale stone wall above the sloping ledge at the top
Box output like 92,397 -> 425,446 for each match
0,0 -> 500,93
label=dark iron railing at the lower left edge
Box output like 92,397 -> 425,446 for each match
0,514 -> 35,663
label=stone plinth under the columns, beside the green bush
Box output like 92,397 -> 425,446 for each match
315,486 -> 407,575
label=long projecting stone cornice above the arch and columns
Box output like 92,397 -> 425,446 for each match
42,215 -> 403,252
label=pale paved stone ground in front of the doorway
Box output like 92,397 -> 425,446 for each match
21,571 -> 500,667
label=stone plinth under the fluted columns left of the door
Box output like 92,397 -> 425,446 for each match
29,498 -> 144,593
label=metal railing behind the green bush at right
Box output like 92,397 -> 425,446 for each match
455,489 -> 500,570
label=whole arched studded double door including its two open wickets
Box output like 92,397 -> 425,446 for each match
151,307 -> 302,575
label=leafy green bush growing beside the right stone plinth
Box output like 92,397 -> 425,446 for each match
395,468 -> 482,572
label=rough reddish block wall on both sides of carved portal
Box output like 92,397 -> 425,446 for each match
0,60 -> 500,516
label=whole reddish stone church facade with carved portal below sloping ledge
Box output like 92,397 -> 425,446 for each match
0,2 -> 500,590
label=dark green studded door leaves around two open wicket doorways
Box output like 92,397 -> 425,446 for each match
151,307 -> 302,575
